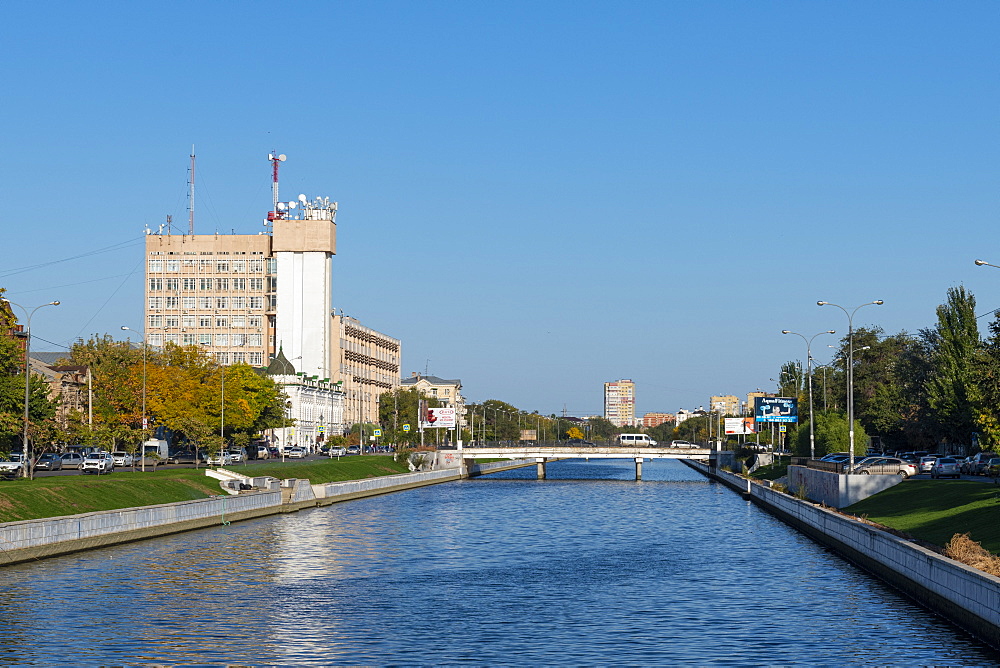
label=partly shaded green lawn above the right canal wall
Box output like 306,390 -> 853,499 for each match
844,480 -> 1000,554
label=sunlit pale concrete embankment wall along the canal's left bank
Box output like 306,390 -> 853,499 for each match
0,461 -> 534,565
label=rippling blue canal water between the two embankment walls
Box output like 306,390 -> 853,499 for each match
0,460 -> 997,666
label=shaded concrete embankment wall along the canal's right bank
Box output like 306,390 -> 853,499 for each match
687,462 -> 1000,648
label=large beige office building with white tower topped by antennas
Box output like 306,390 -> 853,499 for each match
145,189 -> 400,425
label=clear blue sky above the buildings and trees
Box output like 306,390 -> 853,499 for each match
0,1 -> 1000,415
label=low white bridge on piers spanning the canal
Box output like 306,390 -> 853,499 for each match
456,444 -> 714,480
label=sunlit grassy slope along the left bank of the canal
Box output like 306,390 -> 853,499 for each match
0,455 -> 408,522
